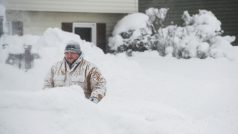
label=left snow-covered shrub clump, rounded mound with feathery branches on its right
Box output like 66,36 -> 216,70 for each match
109,8 -> 168,52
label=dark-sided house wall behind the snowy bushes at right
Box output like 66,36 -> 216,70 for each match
139,0 -> 238,45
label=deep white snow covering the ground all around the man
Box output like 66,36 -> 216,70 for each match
0,29 -> 238,134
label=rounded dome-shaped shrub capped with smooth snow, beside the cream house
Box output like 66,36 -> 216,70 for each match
109,13 -> 151,52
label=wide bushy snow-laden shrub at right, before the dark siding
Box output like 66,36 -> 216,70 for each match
155,10 -> 234,59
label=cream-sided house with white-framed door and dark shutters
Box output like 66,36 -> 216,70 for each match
4,0 -> 138,51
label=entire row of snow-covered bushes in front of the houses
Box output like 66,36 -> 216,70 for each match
109,8 -> 235,59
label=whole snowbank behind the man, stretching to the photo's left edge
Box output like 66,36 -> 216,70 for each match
0,28 -> 107,71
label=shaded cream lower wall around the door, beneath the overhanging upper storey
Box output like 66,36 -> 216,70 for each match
6,10 -> 126,37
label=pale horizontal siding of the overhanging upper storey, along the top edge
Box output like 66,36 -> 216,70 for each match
6,0 -> 138,13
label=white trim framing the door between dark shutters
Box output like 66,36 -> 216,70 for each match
73,22 -> 97,45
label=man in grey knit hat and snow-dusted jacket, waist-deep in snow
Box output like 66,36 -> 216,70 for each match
44,42 -> 106,103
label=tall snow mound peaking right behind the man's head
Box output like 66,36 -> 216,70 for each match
35,28 -> 103,61
